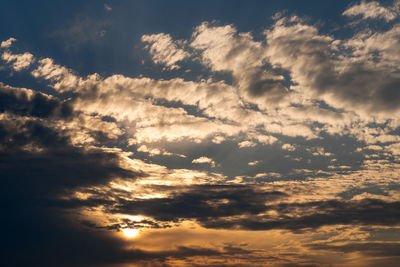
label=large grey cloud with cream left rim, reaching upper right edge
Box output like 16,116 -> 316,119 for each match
267,19 -> 400,111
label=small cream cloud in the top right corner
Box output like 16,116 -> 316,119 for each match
343,1 -> 399,22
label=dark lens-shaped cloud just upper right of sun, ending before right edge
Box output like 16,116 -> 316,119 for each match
112,185 -> 286,221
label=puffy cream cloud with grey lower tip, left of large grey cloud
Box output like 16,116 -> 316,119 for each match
190,23 -> 287,104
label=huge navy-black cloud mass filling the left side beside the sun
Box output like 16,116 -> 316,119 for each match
0,87 -> 146,266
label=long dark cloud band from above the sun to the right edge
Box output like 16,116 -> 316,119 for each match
101,185 -> 400,232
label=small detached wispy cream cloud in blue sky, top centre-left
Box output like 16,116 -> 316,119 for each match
141,33 -> 190,70
